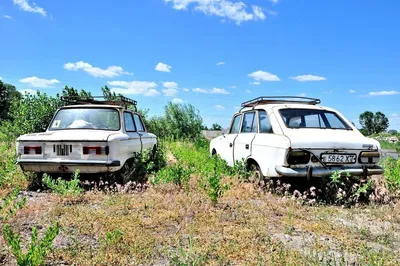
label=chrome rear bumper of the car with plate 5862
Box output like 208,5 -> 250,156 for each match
275,166 -> 383,178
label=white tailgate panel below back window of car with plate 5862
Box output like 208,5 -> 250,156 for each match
285,128 -> 380,150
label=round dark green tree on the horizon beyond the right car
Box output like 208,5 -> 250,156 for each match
360,111 -> 389,135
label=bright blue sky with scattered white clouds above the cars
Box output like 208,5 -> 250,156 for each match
0,0 -> 400,130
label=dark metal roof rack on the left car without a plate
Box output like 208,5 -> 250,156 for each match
61,96 -> 137,110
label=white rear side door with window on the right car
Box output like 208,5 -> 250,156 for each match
233,111 -> 258,162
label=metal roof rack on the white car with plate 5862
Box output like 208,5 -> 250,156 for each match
242,96 -> 321,107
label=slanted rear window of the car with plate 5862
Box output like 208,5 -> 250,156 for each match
279,109 -> 351,130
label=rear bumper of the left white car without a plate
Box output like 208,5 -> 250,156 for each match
17,159 -> 121,174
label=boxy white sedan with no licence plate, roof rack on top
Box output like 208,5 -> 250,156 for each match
16,96 -> 157,181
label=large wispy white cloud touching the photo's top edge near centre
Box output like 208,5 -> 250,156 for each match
164,0 -> 266,24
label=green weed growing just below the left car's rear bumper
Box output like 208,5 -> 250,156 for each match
43,170 -> 83,197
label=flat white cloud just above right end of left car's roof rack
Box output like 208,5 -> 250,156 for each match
108,81 -> 160,96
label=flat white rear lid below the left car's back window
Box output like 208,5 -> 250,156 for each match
17,130 -> 119,141
